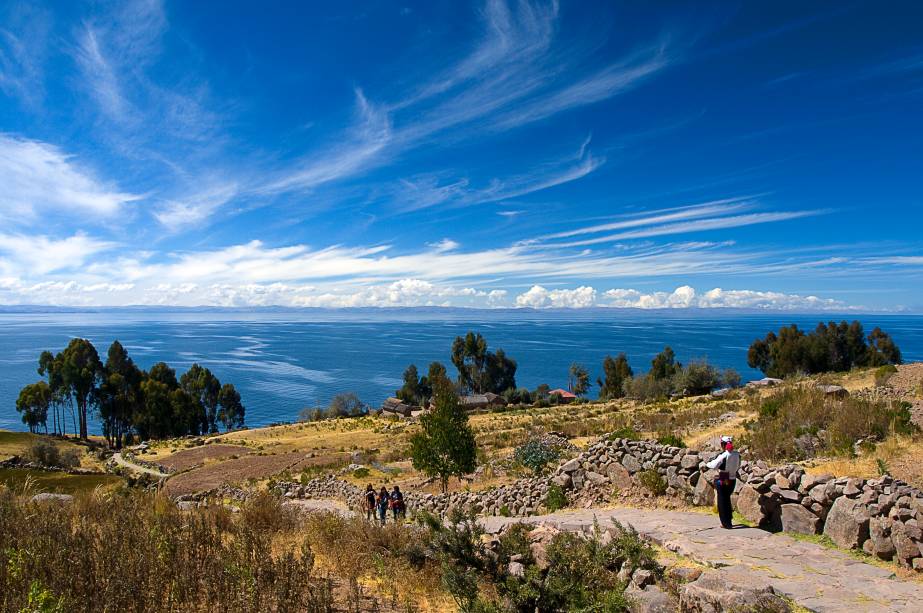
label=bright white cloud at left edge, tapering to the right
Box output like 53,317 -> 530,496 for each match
0,134 -> 141,222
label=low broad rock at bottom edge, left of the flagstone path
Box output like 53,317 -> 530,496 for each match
679,571 -> 792,613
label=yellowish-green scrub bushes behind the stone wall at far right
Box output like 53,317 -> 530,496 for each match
745,386 -> 917,460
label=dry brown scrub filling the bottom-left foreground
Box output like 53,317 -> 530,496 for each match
0,490 -> 332,611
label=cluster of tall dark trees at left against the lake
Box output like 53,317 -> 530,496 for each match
16,338 -> 246,447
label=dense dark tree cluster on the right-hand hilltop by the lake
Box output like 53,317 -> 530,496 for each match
747,321 -> 901,377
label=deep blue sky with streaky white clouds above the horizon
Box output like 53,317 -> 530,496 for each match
0,0 -> 923,312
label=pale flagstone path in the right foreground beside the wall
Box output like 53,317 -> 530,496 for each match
482,508 -> 923,613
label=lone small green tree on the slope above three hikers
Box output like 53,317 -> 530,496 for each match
410,378 -> 477,493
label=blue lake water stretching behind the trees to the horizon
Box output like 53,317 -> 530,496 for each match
0,310 -> 923,433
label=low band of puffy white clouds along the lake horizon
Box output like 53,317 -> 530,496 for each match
0,277 -> 857,311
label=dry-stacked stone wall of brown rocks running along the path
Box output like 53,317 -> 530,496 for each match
277,438 -> 923,570
